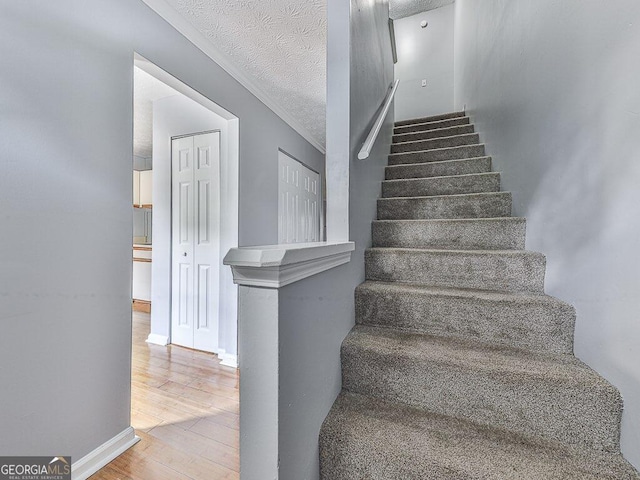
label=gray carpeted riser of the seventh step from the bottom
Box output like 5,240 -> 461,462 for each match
382,173 -> 500,198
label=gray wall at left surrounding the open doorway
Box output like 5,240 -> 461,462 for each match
0,0 -> 323,460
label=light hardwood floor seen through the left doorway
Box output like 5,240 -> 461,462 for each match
90,312 -> 240,480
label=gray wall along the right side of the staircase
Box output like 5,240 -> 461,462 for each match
455,0 -> 640,467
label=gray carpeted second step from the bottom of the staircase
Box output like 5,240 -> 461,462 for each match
342,326 -> 622,452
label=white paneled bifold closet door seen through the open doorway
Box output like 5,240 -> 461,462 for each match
171,132 -> 220,352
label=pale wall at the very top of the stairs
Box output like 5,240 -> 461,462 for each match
394,5 -> 454,120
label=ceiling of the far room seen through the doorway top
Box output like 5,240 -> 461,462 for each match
133,67 -> 179,157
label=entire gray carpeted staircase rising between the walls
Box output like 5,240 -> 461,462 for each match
320,113 -> 640,480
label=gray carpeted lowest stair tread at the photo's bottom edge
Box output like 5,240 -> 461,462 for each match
320,392 -> 640,480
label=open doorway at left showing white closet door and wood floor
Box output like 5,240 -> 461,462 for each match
105,55 -> 239,478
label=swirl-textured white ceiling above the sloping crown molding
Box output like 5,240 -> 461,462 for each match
166,0 -> 327,144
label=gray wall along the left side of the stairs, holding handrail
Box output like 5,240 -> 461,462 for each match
279,0 -> 393,480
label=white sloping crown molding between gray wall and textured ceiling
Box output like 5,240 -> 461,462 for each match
137,0 -> 326,154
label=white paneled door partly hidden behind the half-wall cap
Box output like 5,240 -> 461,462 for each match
278,151 -> 321,243
